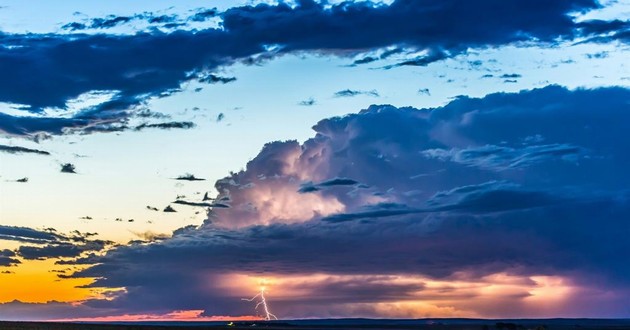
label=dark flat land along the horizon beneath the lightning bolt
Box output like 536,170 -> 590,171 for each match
0,319 -> 630,330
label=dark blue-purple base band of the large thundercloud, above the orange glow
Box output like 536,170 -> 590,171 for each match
87,191 -> 628,278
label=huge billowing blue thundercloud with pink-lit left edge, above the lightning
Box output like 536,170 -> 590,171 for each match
47,86 -> 630,317
